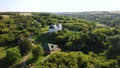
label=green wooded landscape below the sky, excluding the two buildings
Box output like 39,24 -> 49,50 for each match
0,12 -> 120,68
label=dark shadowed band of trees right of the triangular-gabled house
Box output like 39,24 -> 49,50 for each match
37,28 -> 120,53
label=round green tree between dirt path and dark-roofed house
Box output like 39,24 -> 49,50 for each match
32,45 -> 44,58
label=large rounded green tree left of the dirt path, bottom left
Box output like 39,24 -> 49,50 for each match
5,48 -> 21,65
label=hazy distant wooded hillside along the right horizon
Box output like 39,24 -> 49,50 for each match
55,11 -> 120,27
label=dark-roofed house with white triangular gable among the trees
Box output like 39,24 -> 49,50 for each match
42,43 -> 61,53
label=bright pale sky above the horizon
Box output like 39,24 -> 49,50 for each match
0,0 -> 120,12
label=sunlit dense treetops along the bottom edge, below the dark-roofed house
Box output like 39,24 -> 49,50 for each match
35,52 -> 118,68
